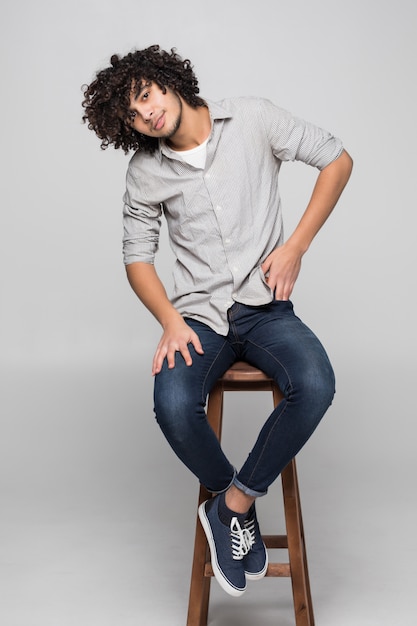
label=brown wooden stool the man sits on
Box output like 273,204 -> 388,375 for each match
187,361 -> 314,626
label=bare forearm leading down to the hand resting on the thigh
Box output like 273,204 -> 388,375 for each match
126,262 -> 181,328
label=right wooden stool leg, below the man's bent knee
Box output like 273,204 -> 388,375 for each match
281,459 -> 314,626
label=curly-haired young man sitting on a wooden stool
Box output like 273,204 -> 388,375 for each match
83,46 -> 352,596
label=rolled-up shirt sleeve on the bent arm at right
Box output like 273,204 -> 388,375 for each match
261,100 -> 343,170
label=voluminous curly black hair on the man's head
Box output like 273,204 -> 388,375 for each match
82,45 -> 206,154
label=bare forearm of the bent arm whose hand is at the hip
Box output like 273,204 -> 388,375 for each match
287,151 -> 353,254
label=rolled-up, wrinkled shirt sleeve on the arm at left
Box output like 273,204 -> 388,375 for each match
123,168 -> 162,265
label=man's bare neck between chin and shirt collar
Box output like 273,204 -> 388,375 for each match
167,100 -> 211,151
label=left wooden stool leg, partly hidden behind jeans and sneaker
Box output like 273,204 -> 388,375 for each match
187,383 -> 223,626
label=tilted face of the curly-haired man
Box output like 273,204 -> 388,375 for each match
129,81 -> 182,139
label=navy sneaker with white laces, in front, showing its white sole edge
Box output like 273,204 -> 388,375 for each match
198,496 -> 251,597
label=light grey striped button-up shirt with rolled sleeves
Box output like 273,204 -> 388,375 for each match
123,98 -> 343,335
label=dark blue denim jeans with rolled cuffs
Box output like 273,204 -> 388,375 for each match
154,300 -> 335,497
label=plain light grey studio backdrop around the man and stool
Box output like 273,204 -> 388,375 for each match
0,0 -> 417,626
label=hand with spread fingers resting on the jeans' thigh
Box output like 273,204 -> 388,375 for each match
152,314 -> 204,376
